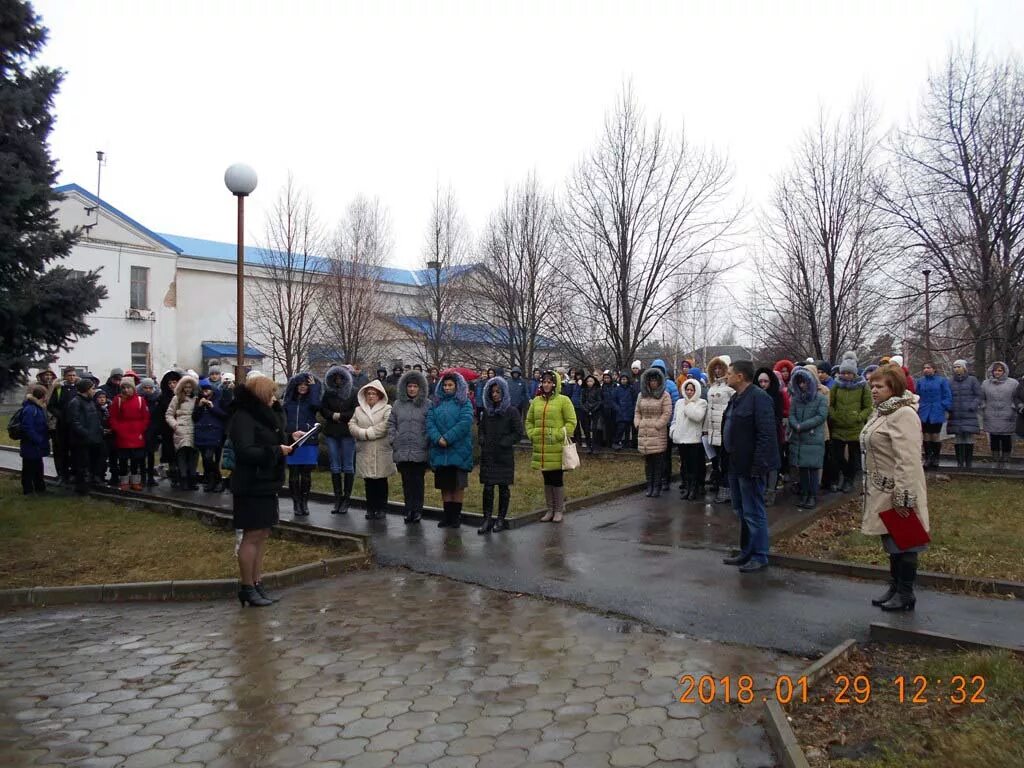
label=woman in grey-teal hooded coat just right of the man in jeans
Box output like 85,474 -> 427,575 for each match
790,368 -> 828,509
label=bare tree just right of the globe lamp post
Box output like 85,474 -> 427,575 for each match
246,174 -> 325,378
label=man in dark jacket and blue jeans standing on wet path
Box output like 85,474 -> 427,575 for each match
722,360 -> 779,573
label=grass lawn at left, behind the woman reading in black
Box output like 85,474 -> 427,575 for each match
0,475 -> 338,589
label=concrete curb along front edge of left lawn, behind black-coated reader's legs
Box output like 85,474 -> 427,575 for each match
0,552 -> 371,608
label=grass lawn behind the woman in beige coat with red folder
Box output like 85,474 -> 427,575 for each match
776,477 -> 1024,582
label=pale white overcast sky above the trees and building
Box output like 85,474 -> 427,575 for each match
35,0 -> 1024,266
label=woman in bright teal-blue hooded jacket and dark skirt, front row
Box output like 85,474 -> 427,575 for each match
427,371 -> 473,528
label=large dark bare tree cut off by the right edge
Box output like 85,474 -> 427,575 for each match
881,46 -> 1024,371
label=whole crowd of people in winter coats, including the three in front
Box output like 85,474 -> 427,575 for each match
12,352 -> 1024,609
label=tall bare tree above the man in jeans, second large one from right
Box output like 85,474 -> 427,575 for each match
749,97 -> 896,360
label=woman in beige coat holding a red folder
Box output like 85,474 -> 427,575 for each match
860,365 -> 928,610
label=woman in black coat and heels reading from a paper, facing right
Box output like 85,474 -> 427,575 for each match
228,376 -> 302,606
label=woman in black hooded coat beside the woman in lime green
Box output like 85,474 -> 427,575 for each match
476,377 -> 525,534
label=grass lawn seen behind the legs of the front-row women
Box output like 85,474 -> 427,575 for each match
313,451 -> 643,517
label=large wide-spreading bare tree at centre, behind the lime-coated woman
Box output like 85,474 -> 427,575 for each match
558,85 -> 738,368
